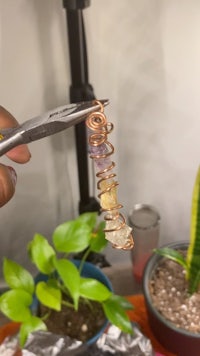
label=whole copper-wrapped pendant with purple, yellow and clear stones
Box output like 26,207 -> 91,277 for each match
86,102 -> 134,250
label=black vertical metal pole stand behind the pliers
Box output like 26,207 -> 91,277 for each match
63,0 -> 100,213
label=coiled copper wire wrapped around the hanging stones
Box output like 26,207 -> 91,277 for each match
86,101 -> 133,250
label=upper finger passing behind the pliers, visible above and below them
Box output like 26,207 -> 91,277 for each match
0,106 -> 31,163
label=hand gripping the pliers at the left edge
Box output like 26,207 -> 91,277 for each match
0,106 -> 31,207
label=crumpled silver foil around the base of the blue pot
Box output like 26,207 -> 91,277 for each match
0,324 -> 156,356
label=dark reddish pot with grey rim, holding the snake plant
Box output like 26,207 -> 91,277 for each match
143,242 -> 200,356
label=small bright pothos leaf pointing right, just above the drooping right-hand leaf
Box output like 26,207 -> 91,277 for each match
80,277 -> 112,302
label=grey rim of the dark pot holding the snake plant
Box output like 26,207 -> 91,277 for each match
142,241 -> 200,339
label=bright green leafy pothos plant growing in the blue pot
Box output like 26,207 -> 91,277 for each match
0,213 -> 132,346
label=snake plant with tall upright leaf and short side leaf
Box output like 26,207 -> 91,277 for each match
155,168 -> 200,294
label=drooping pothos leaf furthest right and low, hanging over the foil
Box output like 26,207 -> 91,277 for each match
103,295 -> 133,334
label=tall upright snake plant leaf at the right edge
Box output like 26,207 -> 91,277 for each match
187,168 -> 200,293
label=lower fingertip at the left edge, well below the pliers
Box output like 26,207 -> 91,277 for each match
0,164 -> 17,207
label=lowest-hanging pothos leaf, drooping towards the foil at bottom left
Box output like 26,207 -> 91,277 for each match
19,316 -> 47,347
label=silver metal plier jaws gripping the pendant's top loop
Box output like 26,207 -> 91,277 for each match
0,100 -> 108,156
